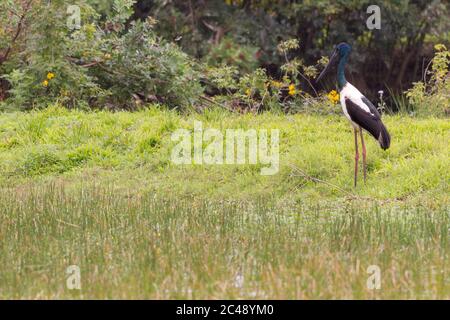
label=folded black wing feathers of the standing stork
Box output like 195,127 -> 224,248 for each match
345,97 -> 391,149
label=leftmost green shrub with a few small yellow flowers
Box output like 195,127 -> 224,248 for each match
0,0 -> 106,109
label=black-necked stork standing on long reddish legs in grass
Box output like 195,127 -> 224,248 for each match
317,42 -> 391,187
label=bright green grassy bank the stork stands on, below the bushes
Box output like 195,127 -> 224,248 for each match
0,108 -> 450,199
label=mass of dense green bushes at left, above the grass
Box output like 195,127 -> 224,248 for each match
0,0 -> 202,108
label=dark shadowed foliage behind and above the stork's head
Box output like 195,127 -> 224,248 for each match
135,0 -> 450,102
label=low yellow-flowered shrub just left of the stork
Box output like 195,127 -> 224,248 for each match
204,39 -> 339,113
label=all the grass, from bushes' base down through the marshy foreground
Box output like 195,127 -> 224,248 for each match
0,107 -> 450,299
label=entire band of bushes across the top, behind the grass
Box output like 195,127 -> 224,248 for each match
0,0 -> 450,114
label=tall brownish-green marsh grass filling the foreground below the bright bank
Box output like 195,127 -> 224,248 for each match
0,183 -> 450,299
